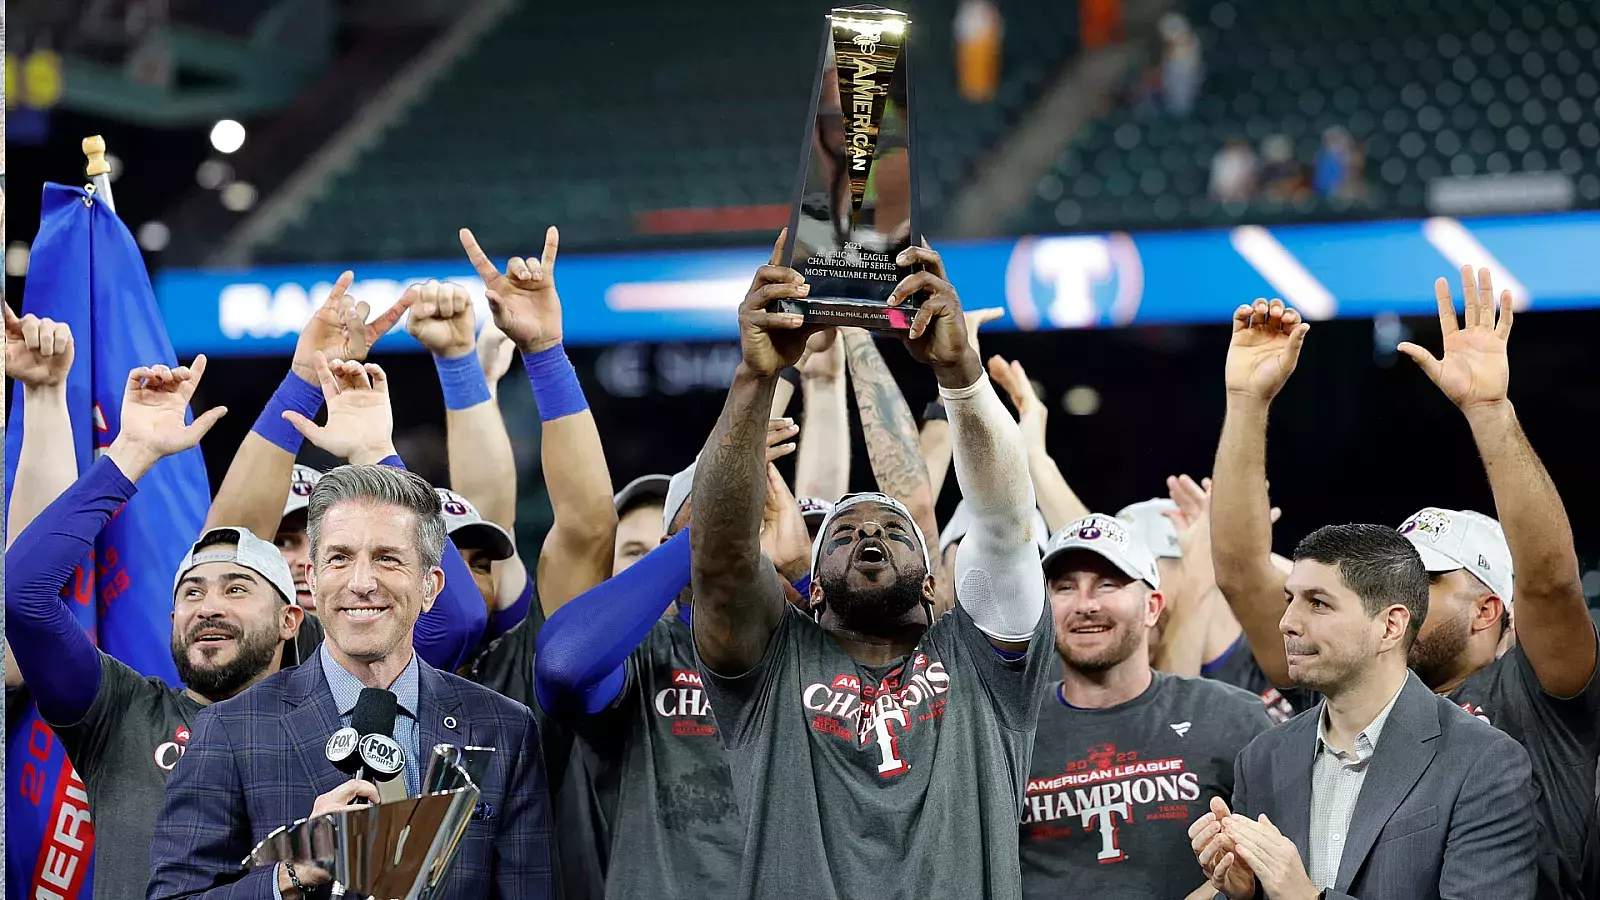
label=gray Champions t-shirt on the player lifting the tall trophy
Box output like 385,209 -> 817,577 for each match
699,595 -> 1056,900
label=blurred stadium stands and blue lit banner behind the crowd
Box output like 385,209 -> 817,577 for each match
5,0 -> 1600,604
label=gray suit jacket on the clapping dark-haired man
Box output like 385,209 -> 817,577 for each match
1219,673 -> 1538,900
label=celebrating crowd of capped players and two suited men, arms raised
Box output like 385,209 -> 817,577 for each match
5,222 -> 1600,900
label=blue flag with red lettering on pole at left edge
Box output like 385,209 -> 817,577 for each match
5,184 -> 211,900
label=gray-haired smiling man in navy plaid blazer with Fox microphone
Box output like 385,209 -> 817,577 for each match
147,360 -> 555,900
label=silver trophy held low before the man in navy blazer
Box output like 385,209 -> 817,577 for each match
242,743 -> 493,900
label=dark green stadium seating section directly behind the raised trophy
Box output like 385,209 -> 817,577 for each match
259,0 -> 1077,261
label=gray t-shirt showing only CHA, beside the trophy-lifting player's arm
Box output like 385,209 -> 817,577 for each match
576,615 -> 744,900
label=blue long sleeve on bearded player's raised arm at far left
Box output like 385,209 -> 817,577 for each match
5,456 -> 138,725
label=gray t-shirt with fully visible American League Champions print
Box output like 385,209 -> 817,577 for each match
1021,673 -> 1272,900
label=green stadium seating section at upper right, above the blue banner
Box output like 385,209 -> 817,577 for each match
1010,0 -> 1600,232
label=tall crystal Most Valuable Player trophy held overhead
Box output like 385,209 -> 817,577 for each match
773,6 -> 922,331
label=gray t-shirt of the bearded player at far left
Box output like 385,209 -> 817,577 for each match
53,653 -> 200,900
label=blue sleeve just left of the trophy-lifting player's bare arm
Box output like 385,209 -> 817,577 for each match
533,528 -> 690,716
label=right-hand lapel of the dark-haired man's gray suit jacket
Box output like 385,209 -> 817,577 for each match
1333,673 -> 1440,892
